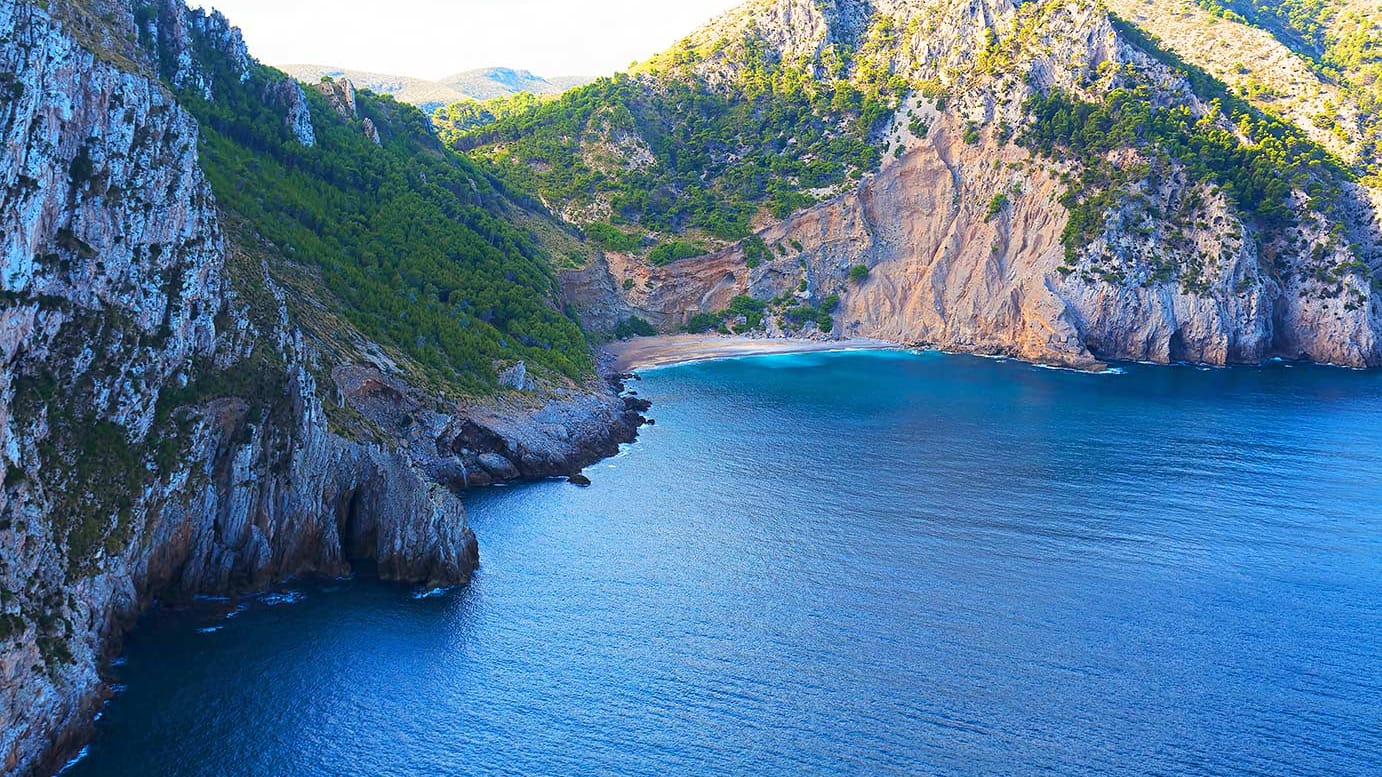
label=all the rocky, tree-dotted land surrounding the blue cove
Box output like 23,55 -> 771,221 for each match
0,0 -> 1382,774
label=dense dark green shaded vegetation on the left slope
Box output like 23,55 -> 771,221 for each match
155,9 -> 593,391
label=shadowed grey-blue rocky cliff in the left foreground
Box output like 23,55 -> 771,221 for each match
0,0 -> 638,774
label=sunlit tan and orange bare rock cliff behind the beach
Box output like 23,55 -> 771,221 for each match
565,0 -> 1382,368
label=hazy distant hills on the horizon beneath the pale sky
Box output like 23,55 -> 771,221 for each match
278,65 -> 593,112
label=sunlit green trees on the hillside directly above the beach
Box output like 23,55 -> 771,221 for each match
434,12 -> 909,254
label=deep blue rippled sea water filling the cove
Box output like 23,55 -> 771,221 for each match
69,354 -> 1382,776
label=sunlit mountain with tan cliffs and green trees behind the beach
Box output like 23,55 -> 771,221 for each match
461,0 -> 1382,366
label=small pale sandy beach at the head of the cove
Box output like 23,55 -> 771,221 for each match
604,335 -> 901,372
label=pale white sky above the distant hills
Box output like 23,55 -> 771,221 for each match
191,0 -> 742,79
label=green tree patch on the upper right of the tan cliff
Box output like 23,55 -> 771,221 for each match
1019,18 -> 1365,292
